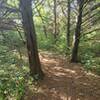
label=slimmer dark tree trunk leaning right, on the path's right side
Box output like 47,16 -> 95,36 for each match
71,0 -> 84,62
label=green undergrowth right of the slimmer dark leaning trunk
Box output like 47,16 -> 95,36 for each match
79,41 -> 100,75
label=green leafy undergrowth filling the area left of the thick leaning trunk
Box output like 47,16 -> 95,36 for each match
0,32 -> 29,100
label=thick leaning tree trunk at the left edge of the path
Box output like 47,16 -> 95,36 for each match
20,0 -> 43,79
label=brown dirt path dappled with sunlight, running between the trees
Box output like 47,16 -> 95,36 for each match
24,53 -> 100,100
